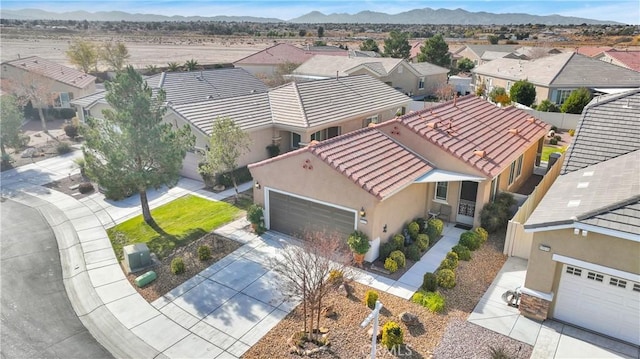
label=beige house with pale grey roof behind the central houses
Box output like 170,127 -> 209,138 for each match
291,55 -> 449,98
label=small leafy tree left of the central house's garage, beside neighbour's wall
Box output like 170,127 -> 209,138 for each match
202,117 -> 251,200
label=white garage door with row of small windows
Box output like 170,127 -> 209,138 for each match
554,264 -> 640,345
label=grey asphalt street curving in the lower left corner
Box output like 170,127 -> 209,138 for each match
0,200 -> 112,359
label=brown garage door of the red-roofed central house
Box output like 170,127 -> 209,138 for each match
269,191 -> 356,238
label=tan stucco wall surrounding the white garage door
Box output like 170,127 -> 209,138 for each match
525,228 -> 640,304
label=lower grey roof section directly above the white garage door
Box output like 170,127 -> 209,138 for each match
524,150 -> 640,241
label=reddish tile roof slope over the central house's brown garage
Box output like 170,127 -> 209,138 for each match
249,127 -> 433,199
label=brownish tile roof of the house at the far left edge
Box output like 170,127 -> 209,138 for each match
2,56 -> 96,89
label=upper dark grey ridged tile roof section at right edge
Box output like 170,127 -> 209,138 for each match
562,89 -> 640,173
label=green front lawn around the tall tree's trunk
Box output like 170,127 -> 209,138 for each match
107,195 -> 241,260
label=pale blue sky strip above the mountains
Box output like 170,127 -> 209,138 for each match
0,0 -> 640,25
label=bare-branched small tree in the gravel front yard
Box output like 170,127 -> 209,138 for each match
271,232 -> 349,338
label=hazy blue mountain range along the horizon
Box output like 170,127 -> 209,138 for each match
0,8 -> 619,25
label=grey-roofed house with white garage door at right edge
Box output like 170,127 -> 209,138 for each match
520,90 -> 640,345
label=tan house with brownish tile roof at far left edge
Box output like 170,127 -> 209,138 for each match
0,56 -> 96,108
